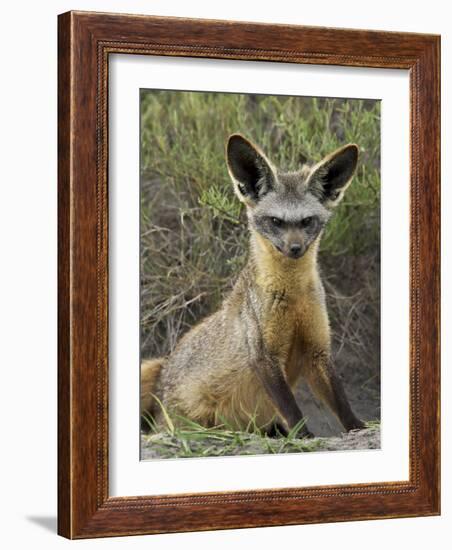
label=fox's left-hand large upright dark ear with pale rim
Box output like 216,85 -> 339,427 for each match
226,134 -> 275,204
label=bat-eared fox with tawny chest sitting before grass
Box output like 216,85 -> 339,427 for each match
141,134 -> 364,437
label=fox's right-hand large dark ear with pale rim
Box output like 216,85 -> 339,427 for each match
309,143 -> 358,208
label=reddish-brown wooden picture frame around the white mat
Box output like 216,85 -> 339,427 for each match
58,12 -> 440,538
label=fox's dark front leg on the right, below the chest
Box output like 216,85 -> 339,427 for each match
304,351 -> 364,431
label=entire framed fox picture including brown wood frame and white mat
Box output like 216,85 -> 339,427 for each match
58,12 -> 440,538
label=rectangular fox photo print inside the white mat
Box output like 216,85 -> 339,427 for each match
140,90 -> 380,459
